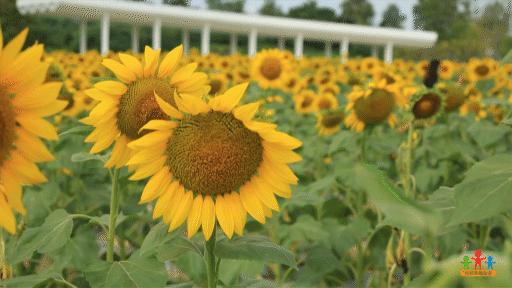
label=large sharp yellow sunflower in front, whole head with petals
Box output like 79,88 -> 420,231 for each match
128,83 -> 302,240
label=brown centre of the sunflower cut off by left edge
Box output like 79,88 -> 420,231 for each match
0,88 -> 16,167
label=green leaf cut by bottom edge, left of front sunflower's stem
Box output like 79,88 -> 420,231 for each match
85,258 -> 168,288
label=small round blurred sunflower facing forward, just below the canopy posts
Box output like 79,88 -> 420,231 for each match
251,49 -> 290,89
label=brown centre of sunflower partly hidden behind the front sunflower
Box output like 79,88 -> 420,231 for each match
117,78 -> 176,139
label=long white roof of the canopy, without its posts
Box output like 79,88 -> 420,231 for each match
17,0 -> 437,48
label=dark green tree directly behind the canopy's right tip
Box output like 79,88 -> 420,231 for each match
413,0 -> 464,40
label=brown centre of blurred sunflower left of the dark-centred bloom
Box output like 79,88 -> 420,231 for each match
354,89 -> 395,125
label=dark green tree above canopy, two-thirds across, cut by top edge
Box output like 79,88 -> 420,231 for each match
341,0 -> 375,25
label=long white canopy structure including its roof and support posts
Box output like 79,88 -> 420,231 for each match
16,0 -> 437,62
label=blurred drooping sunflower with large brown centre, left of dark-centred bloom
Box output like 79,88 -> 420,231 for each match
344,80 -> 407,132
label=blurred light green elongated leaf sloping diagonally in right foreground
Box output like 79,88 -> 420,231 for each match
355,164 -> 441,234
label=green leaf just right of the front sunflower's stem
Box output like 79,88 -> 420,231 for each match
215,236 -> 297,268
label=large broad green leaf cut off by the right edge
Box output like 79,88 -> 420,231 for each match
449,154 -> 512,225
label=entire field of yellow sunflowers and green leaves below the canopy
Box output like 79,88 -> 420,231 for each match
0,25 -> 512,288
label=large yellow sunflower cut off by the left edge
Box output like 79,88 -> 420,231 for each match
0,29 -> 67,234
